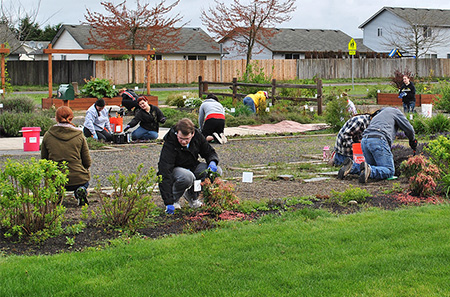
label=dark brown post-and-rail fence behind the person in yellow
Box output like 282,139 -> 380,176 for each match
198,76 -> 322,115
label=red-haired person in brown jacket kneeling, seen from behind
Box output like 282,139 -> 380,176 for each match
41,106 -> 91,206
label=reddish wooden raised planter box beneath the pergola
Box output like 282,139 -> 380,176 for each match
42,95 -> 158,110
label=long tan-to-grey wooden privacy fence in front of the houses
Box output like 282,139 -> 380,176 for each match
95,58 -> 450,84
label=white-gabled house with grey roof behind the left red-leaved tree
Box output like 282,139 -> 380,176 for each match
51,25 -> 220,60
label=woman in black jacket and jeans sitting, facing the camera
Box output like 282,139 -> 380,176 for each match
124,96 -> 166,140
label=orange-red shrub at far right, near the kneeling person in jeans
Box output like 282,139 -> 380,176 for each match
400,155 -> 440,196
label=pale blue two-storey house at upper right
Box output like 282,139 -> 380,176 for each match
359,7 -> 450,58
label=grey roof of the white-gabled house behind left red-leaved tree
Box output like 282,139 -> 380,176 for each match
52,25 -> 220,54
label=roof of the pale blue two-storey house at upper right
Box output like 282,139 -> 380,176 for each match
358,6 -> 450,29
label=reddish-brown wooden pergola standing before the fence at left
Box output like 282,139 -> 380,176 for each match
43,44 -> 155,98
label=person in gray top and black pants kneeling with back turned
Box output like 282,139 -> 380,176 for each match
198,94 -> 227,144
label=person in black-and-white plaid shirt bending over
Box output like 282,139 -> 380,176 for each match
333,110 -> 379,179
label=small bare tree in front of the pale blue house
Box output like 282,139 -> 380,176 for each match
383,9 -> 449,74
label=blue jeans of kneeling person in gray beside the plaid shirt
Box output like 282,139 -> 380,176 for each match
361,137 -> 395,179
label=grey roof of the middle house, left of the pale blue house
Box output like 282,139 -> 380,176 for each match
263,28 -> 373,53
